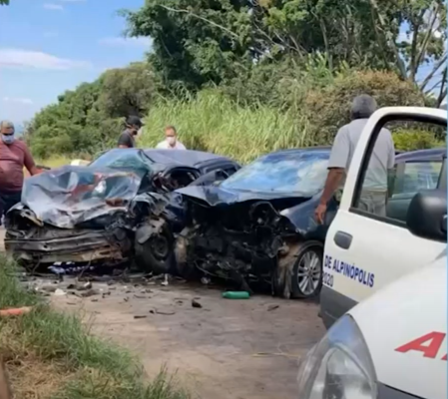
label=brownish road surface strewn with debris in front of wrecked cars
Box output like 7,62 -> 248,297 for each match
53,283 -> 323,399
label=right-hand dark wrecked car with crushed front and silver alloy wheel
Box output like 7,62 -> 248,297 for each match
174,148 -> 337,298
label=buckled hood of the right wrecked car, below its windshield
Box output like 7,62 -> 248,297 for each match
176,185 -> 312,206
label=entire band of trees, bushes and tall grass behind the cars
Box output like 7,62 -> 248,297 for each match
20,0 -> 447,164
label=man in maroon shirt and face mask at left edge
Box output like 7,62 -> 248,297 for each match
0,121 -> 41,222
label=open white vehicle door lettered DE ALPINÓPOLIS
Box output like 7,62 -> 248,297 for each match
320,107 -> 446,326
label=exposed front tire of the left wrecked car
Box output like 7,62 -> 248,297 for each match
134,226 -> 174,275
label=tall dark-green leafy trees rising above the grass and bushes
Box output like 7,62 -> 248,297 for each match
124,0 -> 446,104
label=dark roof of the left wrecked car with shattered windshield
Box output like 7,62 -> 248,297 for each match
143,149 -> 236,168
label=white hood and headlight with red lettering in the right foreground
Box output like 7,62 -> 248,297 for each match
297,241 -> 447,399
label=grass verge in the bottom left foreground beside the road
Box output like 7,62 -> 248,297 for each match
0,256 -> 189,399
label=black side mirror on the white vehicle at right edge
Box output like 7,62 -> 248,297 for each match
406,190 -> 447,242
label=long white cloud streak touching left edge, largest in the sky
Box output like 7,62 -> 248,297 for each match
0,48 -> 91,70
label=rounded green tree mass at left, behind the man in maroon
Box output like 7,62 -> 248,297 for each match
25,63 -> 155,158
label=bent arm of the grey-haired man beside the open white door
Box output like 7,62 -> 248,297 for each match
320,128 -> 350,205
